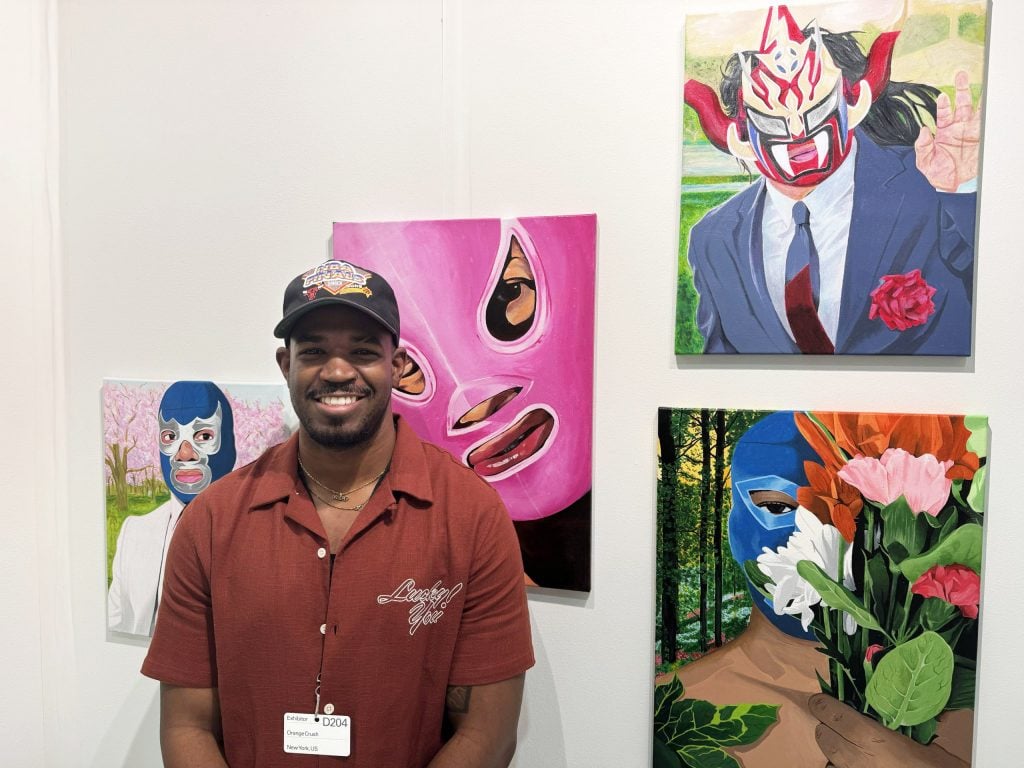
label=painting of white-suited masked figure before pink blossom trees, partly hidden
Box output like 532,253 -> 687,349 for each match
101,379 -> 295,637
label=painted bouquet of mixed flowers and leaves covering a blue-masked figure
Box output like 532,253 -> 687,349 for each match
744,413 -> 988,743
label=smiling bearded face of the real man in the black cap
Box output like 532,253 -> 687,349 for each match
278,306 -> 406,449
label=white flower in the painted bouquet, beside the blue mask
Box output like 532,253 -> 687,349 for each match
758,507 -> 857,635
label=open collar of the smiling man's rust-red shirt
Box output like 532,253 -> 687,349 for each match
250,416 -> 433,508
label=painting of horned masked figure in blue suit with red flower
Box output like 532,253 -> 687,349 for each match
675,0 -> 987,356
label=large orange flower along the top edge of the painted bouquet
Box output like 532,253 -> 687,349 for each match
796,413 -> 979,480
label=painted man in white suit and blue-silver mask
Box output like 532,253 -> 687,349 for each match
106,381 -> 236,635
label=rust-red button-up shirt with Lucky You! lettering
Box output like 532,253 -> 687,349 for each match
142,419 -> 534,768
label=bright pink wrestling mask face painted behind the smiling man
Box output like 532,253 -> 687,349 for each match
334,216 -> 596,520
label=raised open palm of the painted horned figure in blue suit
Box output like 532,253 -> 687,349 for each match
913,72 -> 981,191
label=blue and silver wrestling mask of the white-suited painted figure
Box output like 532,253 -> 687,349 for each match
157,381 -> 234,504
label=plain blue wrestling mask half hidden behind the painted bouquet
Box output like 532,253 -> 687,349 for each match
729,411 -> 818,640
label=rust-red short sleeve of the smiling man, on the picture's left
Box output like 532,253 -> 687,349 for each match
142,499 -> 217,688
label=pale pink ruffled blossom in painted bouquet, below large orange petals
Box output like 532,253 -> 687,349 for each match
839,449 -> 953,517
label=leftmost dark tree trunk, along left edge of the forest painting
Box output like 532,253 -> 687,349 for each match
657,408 -> 679,664
